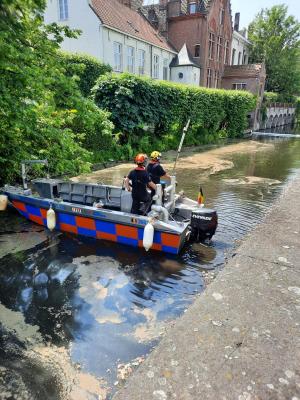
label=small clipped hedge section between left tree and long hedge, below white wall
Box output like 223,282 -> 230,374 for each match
60,52 -> 112,97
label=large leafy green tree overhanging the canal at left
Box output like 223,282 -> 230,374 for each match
0,0 -> 112,184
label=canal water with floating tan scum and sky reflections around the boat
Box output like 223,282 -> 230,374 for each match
0,131 -> 300,400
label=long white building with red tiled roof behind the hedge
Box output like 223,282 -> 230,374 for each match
44,0 -> 177,80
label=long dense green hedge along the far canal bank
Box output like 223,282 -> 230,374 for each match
92,74 -> 255,145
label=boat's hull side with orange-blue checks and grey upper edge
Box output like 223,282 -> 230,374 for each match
6,192 -> 186,254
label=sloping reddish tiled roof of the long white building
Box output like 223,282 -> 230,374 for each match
90,0 -> 175,53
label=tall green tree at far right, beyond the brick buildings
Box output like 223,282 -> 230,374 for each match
249,5 -> 300,100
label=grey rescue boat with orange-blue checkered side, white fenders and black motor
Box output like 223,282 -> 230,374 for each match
0,160 -> 218,254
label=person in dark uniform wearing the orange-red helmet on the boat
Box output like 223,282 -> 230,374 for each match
125,154 -> 156,215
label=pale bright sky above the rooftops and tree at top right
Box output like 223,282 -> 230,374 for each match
144,0 -> 300,28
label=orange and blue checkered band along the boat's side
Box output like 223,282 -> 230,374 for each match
12,201 -> 180,254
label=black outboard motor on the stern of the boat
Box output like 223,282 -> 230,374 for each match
190,208 -> 218,242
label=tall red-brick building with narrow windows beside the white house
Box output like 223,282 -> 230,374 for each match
141,0 -> 232,88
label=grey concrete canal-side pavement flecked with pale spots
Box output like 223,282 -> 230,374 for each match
114,178 -> 300,400
